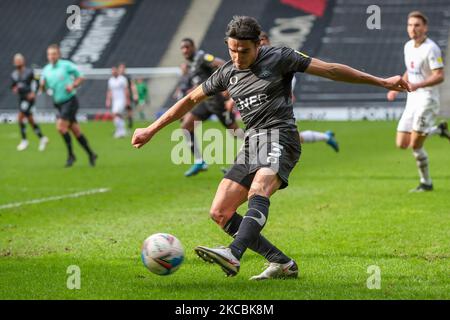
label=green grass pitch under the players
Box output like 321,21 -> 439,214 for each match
0,122 -> 450,299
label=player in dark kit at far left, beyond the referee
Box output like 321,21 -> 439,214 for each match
11,53 -> 48,151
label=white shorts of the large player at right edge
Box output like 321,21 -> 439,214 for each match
397,92 -> 439,134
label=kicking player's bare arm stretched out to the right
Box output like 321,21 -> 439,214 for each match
305,58 -> 411,91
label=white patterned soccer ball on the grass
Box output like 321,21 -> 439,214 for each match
141,233 -> 184,276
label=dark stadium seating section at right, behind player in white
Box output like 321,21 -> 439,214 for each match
296,0 -> 450,106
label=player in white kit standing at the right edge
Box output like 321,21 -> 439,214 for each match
387,11 -> 450,192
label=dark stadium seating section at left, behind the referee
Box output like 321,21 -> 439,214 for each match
0,0 -> 190,110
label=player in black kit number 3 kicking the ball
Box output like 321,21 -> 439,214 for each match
132,16 -> 410,280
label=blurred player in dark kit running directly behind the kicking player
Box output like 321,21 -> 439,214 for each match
180,38 -> 243,177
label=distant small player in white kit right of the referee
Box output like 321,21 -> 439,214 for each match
106,67 -> 130,138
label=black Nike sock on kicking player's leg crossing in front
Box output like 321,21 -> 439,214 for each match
230,195 -> 270,259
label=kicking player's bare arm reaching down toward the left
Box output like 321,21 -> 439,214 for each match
131,85 -> 207,148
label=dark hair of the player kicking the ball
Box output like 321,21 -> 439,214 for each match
225,16 -> 261,42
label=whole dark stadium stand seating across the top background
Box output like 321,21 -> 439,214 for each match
0,0 -> 450,118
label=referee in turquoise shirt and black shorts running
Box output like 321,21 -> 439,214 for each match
41,44 -> 97,167
